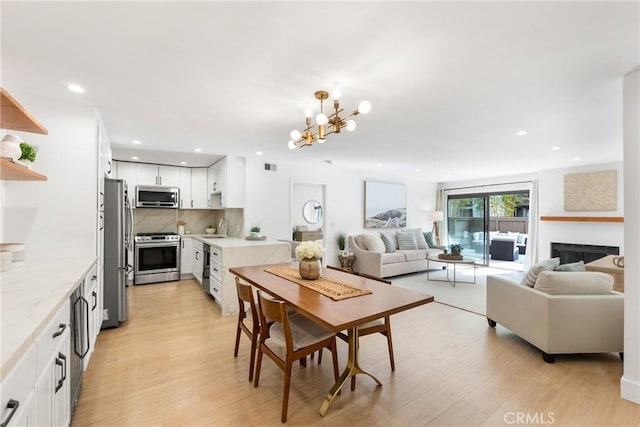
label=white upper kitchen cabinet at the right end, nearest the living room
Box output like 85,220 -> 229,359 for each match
207,156 -> 245,209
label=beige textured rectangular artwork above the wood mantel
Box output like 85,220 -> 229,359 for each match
564,170 -> 617,212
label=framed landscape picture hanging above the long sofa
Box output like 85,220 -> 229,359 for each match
364,181 -> 407,228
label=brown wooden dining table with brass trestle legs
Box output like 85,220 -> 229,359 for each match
229,262 -> 433,416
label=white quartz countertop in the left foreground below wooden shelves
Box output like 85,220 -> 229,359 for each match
0,257 -> 96,379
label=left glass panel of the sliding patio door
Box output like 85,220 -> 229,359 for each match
447,195 -> 489,265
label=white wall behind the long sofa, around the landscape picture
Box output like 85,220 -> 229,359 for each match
245,157 -> 436,265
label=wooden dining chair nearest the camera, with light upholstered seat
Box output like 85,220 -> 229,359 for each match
253,291 -> 339,423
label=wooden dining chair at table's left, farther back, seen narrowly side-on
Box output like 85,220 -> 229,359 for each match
233,277 -> 260,381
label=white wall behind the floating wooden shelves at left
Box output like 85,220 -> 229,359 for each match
0,93 -> 97,259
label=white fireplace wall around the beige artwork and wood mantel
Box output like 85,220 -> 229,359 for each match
538,162 -> 624,259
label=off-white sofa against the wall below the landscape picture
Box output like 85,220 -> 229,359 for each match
349,229 -> 443,278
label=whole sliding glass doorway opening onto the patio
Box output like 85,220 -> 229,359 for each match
447,190 -> 529,270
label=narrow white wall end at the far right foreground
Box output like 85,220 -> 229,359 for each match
620,71 -> 640,403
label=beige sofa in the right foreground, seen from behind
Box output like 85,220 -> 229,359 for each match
487,271 -> 624,363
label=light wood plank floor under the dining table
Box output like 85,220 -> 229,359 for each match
72,280 -> 640,427
